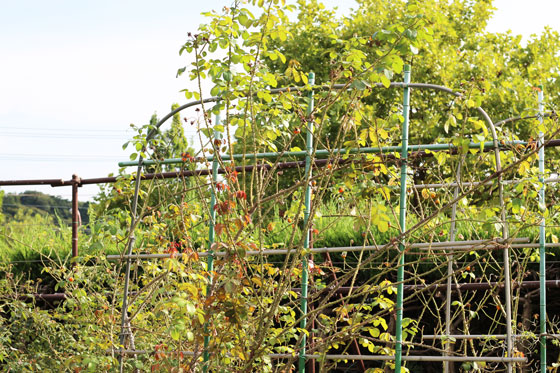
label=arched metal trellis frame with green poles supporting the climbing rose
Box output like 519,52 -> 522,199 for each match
94,66 -> 547,373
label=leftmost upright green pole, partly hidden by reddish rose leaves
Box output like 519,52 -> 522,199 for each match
202,113 -> 221,372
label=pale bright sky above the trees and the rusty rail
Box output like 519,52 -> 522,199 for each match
0,0 -> 560,201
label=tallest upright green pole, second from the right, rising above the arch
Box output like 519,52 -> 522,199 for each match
395,65 -> 410,373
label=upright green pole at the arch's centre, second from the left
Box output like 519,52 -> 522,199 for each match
299,73 -> 315,373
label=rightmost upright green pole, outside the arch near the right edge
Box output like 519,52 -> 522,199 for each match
538,85 -> 546,373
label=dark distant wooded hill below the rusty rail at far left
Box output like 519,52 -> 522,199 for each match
2,191 -> 89,224
